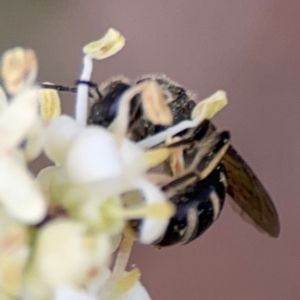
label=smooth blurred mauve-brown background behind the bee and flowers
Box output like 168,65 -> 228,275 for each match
0,0 -> 300,300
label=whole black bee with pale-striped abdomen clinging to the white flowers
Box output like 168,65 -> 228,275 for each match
41,75 -> 280,247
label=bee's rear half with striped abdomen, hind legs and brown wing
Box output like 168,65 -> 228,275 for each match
149,120 -> 280,247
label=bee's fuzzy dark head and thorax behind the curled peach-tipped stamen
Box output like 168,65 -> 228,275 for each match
88,75 -> 196,142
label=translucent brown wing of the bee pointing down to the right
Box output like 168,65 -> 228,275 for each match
222,146 -> 280,237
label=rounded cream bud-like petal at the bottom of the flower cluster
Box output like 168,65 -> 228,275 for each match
34,219 -> 110,287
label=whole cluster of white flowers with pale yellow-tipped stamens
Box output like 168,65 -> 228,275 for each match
0,29 -> 226,300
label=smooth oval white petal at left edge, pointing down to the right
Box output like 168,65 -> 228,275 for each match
0,156 -> 47,224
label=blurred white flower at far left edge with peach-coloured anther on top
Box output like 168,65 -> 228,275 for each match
0,48 -> 46,224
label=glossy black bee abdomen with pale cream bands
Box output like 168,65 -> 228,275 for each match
156,164 -> 226,247
